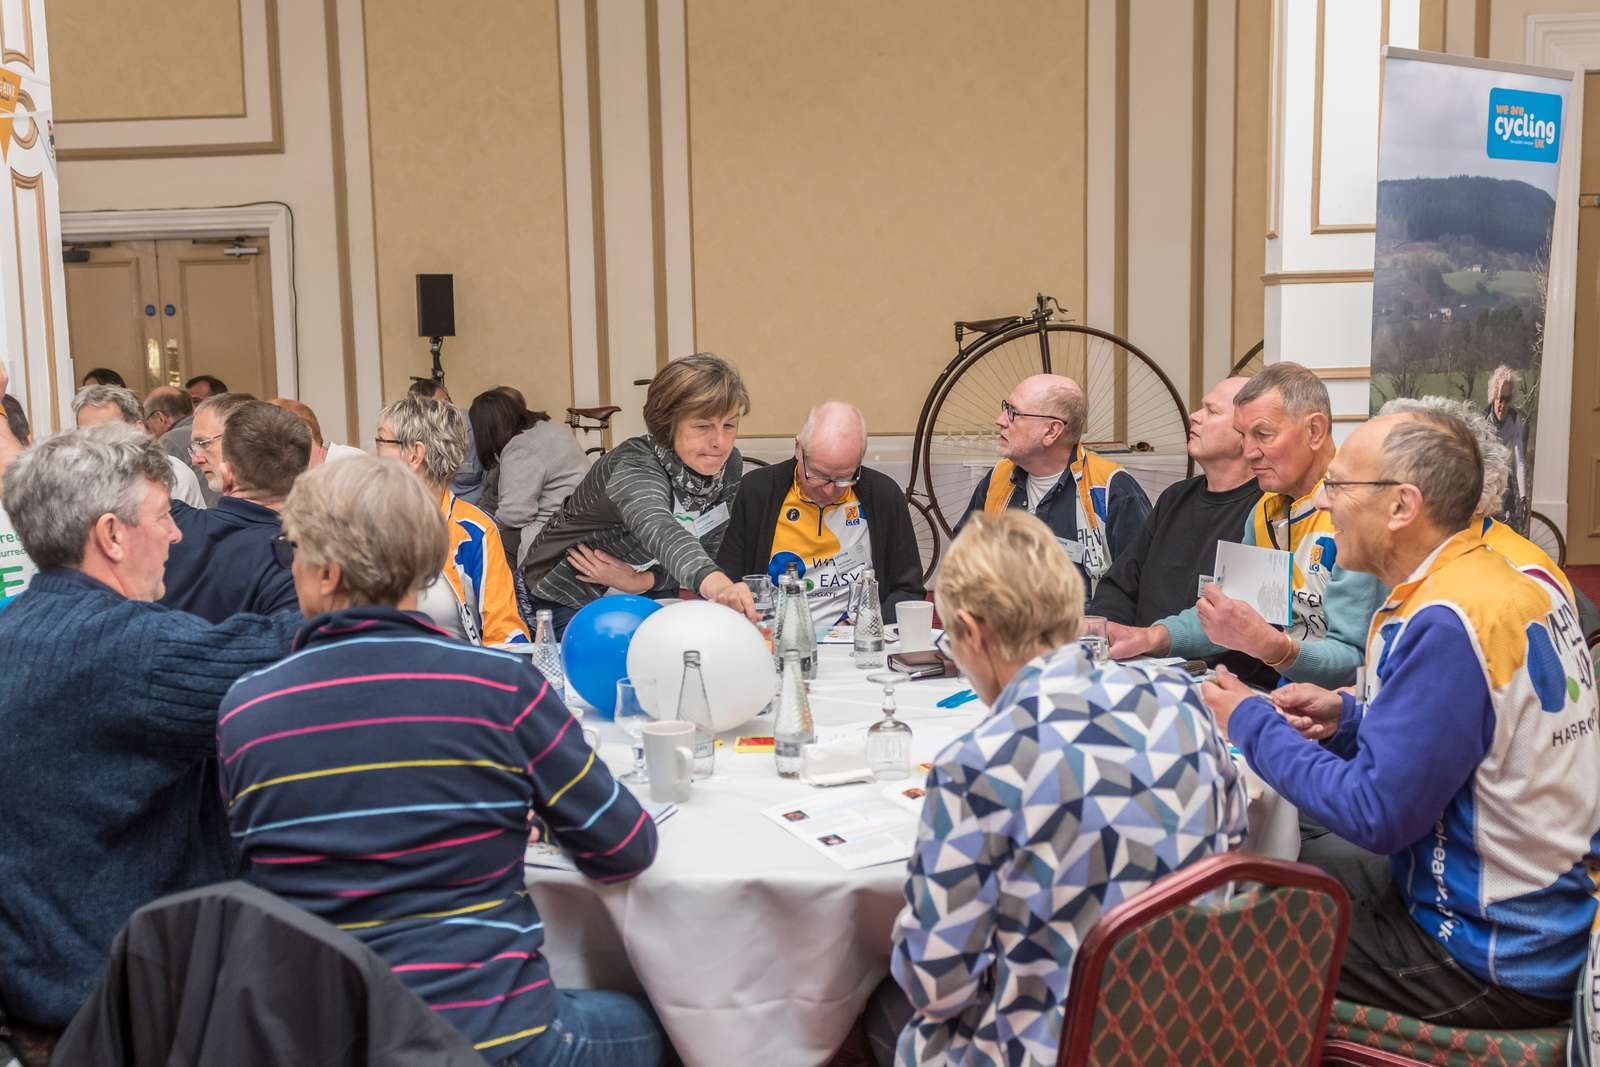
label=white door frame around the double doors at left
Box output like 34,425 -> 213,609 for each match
61,203 -> 299,400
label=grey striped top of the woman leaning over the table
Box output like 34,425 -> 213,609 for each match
522,434 -> 744,608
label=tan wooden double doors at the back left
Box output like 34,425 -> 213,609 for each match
64,237 -> 278,398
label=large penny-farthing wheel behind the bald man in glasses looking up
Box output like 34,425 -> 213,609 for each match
915,322 -> 1194,534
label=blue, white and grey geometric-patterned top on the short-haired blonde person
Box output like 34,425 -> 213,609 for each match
890,641 -> 1246,1065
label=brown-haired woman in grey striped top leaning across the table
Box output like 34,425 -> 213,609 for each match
523,352 -> 757,632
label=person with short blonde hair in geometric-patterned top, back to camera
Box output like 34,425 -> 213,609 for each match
867,510 -> 1246,1064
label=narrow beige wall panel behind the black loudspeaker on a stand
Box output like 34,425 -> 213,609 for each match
366,0 -> 573,414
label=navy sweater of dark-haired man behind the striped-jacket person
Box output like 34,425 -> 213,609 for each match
162,496 -> 299,622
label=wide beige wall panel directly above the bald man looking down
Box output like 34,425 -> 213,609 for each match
688,0 -> 1085,435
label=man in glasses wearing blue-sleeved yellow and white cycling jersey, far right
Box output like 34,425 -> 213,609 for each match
1205,413 -> 1600,1029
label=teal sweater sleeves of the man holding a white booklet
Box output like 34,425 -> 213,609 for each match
1157,514 -> 1389,689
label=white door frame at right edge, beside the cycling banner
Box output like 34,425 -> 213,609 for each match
1523,13 -> 1600,530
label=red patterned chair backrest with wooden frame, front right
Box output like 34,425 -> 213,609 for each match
1058,853 -> 1350,1067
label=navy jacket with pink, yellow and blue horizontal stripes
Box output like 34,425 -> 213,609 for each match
218,606 -> 656,1061
